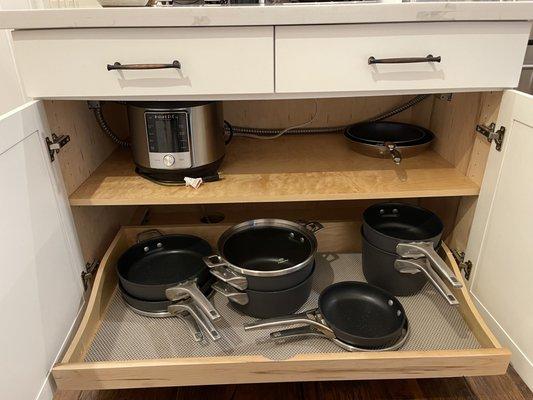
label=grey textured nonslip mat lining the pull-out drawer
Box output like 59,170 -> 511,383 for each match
85,253 -> 480,362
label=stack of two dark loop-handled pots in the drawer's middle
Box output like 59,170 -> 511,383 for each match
204,219 -> 321,318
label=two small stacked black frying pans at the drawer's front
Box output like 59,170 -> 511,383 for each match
244,281 -> 407,349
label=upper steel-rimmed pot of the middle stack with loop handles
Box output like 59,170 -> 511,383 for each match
204,219 -> 322,291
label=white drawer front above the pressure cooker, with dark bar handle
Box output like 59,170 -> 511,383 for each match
13,26 -> 274,98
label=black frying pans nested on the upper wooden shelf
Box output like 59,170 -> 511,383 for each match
344,122 -> 435,164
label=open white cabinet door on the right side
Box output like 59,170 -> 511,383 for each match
466,91 -> 533,388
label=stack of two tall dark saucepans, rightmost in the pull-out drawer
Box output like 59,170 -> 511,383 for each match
362,203 -> 462,305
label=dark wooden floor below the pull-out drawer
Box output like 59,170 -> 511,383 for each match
54,368 -> 533,400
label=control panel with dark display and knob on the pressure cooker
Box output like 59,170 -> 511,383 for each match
144,110 -> 192,169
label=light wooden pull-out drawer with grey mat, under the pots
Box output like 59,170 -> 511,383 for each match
53,222 -> 510,389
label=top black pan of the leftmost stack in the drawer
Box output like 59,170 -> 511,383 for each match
117,230 -> 220,320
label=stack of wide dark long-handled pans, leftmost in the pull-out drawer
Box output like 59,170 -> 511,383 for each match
117,230 -> 220,341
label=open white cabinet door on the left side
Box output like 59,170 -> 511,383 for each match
0,102 -> 83,400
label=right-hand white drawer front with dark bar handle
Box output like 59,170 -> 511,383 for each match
275,22 -> 530,93
